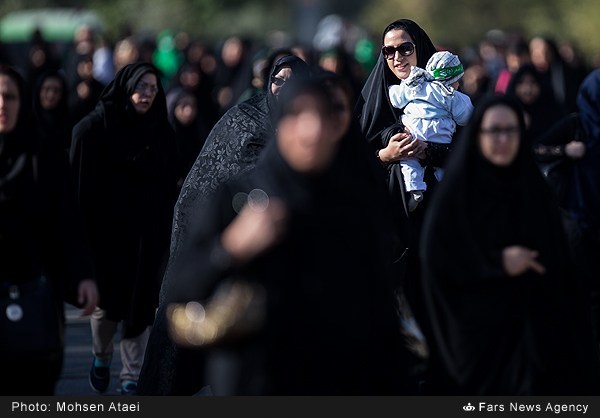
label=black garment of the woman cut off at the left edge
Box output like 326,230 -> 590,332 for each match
0,66 -> 93,395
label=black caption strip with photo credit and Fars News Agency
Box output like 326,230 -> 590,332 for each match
0,396 -> 600,418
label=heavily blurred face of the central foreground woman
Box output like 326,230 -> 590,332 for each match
277,94 -> 341,174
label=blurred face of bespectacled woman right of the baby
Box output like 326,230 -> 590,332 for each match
479,105 -> 521,167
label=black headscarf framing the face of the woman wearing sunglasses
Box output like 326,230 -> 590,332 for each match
354,19 -> 436,145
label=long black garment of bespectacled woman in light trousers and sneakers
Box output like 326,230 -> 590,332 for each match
71,63 -> 177,337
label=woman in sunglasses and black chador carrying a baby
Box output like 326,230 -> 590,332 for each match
355,19 -> 449,386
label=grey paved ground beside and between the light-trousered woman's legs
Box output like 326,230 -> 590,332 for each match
55,305 -> 121,396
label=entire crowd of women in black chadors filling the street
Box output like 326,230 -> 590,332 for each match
0,14 -> 600,395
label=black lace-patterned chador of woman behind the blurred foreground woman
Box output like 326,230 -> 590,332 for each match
138,55 -> 308,395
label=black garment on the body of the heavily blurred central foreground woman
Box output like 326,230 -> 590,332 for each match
167,76 -> 407,395
